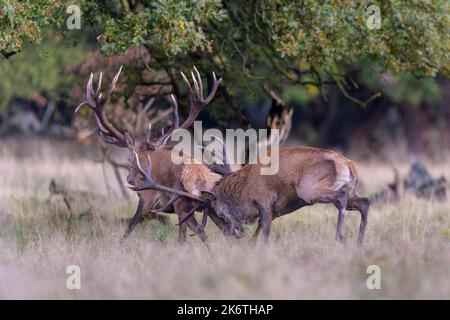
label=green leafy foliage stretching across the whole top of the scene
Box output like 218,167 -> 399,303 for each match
0,0 -> 450,115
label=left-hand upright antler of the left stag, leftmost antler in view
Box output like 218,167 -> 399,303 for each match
75,66 -> 127,147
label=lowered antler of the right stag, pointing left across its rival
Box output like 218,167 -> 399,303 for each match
128,152 -> 206,205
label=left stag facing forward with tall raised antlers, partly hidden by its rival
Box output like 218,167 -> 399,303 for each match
75,67 -> 232,241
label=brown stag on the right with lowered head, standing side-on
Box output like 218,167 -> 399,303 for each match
131,147 -> 370,245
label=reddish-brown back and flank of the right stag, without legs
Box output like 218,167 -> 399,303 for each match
213,147 -> 358,203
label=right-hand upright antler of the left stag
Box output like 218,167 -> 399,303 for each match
156,66 -> 222,148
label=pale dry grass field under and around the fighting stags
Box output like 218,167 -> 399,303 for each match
0,140 -> 450,299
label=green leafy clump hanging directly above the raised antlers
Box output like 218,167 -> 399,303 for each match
101,0 -> 225,55
